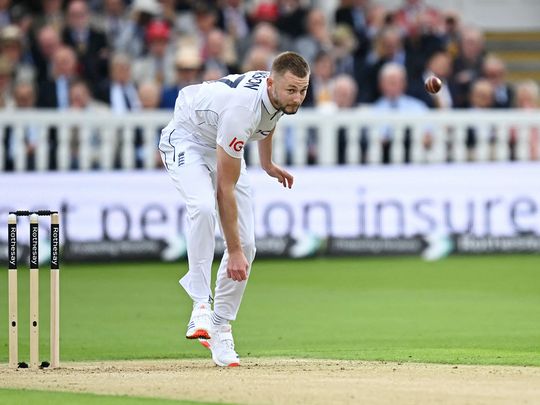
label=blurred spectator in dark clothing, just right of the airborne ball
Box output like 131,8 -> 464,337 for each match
452,27 -> 484,108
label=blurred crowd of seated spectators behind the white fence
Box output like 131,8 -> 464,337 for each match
0,0 -> 540,168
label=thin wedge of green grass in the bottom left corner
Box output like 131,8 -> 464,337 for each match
0,389 -> 224,405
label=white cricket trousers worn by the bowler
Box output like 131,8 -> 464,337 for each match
159,127 -> 255,321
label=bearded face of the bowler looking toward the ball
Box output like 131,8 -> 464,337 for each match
268,72 -> 309,114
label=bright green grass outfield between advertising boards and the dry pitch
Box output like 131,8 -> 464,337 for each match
0,255 -> 540,366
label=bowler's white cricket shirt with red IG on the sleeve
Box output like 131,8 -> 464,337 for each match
167,71 -> 283,158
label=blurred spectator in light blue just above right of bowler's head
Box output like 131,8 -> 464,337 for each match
294,8 -> 332,65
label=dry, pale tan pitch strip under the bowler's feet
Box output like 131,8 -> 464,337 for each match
0,358 -> 540,405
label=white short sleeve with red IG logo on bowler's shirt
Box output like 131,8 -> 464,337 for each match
216,107 -> 255,159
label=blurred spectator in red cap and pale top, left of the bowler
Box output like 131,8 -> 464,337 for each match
133,21 -> 174,86
